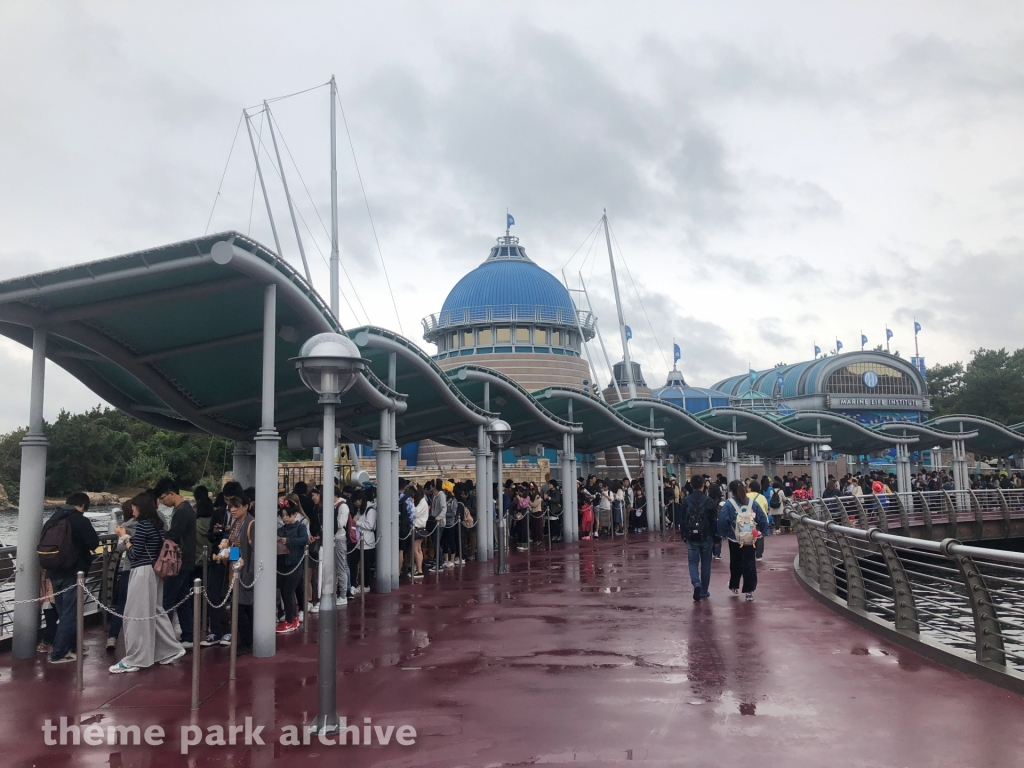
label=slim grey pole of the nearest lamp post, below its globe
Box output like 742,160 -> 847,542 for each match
311,402 -> 338,733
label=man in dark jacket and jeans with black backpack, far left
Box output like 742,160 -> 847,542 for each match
37,492 -> 99,664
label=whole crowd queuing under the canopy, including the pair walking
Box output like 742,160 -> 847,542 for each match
61,456 -> 1022,674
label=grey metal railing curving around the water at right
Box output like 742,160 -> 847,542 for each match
787,490 -> 1024,692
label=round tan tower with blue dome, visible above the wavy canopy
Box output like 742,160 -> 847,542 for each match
423,236 -> 595,392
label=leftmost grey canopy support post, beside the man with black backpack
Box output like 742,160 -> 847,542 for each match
12,328 -> 49,658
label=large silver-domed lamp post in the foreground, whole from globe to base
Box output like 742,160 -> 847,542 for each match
292,333 -> 368,733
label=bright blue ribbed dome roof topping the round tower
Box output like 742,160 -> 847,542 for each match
441,238 -> 575,324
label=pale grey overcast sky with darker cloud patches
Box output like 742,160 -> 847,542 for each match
0,0 -> 1024,430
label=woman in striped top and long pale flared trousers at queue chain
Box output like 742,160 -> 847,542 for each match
110,494 -> 187,675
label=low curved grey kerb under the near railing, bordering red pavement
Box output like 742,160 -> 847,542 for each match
793,556 -> 1024,696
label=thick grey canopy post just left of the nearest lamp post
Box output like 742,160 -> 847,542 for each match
253,284 -> 281,658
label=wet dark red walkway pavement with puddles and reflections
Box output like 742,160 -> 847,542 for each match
0,537 -> 1024,768
